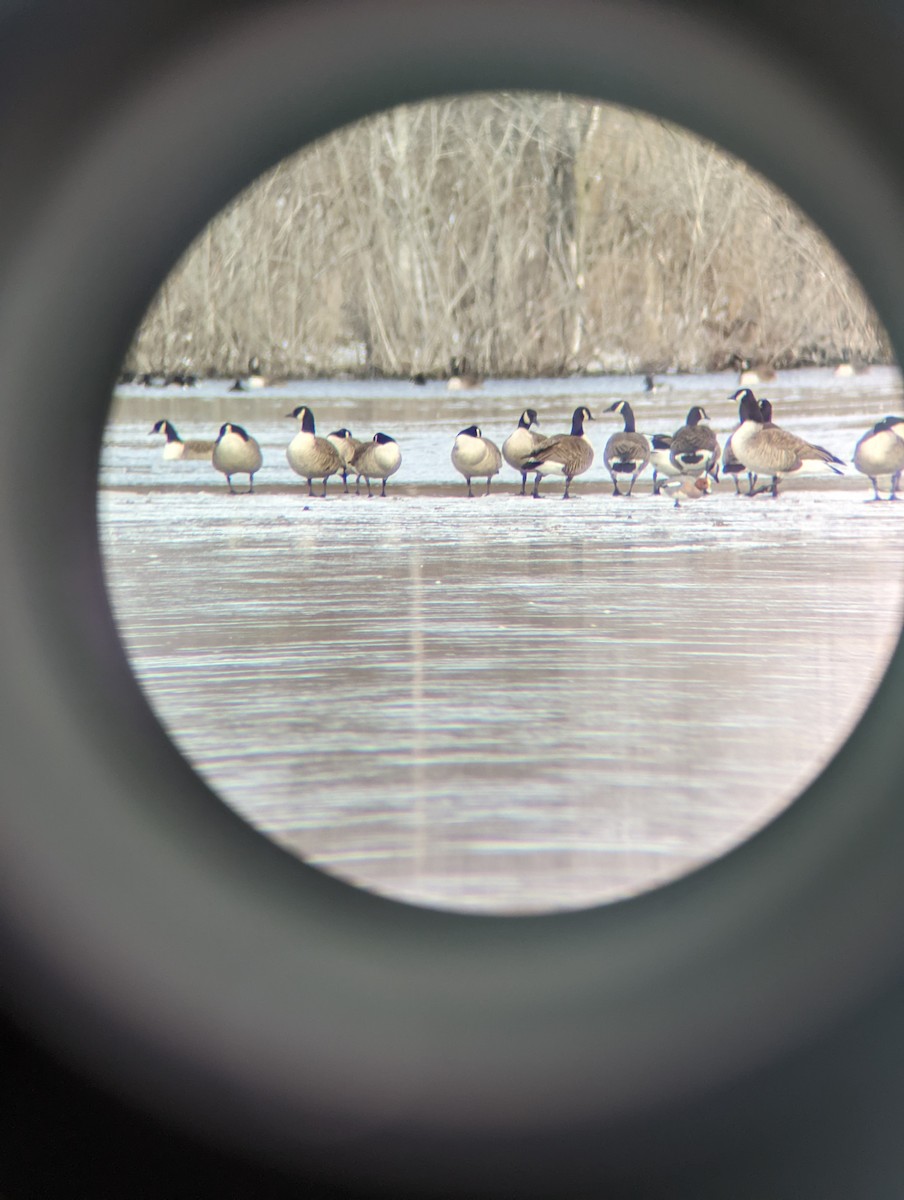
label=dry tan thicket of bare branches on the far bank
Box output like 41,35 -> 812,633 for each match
127,94 -> 891,377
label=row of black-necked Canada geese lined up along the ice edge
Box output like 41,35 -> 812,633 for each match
151,388 -> 904,506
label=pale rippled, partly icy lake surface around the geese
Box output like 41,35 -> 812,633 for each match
98,368 -> 904,912
